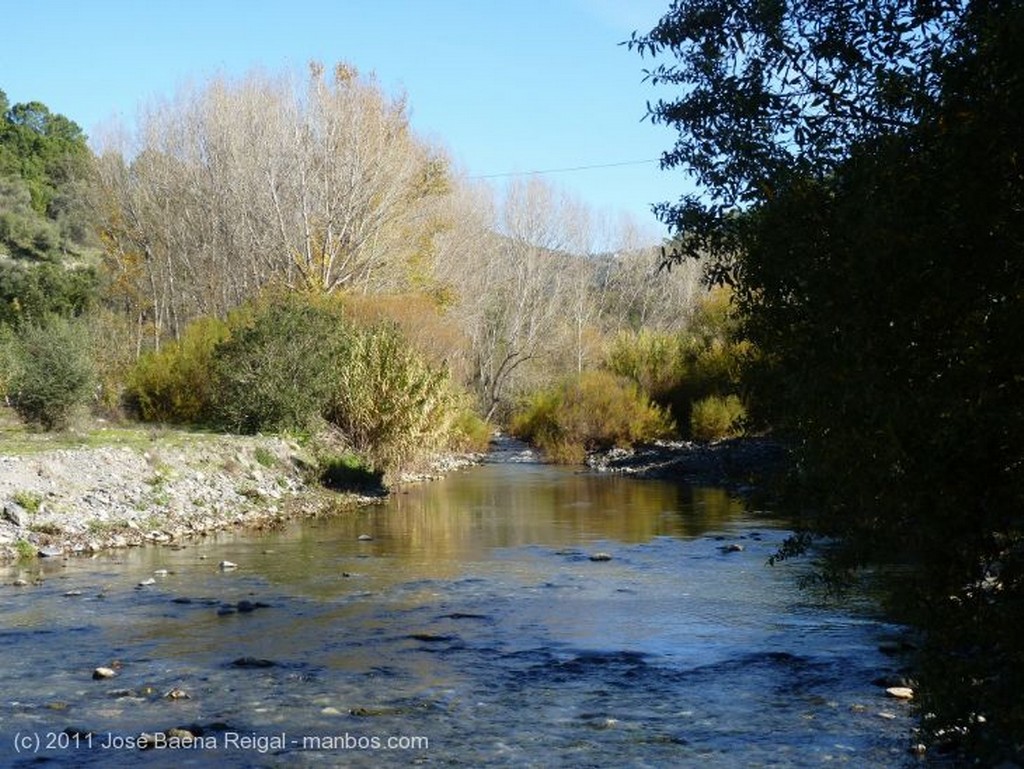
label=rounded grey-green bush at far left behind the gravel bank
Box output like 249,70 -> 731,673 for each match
10,316 -> 94,430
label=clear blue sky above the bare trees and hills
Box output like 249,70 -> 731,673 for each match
0,0 -> 687,238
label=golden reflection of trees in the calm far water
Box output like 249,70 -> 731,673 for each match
332,467 -> 743,570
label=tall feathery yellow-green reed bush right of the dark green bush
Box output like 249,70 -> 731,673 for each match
325,324 -> 464,473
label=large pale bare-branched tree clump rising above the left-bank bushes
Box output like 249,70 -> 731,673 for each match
100,63 -> 451,333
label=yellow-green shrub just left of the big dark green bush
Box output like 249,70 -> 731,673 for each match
125,317 -> 228,424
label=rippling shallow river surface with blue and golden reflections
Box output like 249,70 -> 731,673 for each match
0,456 -> 912,769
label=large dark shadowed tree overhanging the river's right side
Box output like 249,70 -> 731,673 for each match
631,0 -> 1024,759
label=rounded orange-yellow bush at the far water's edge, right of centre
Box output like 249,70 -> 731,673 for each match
512,372 -> 674,463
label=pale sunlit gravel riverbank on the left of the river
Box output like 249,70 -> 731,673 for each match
0,417 -> 481,561
